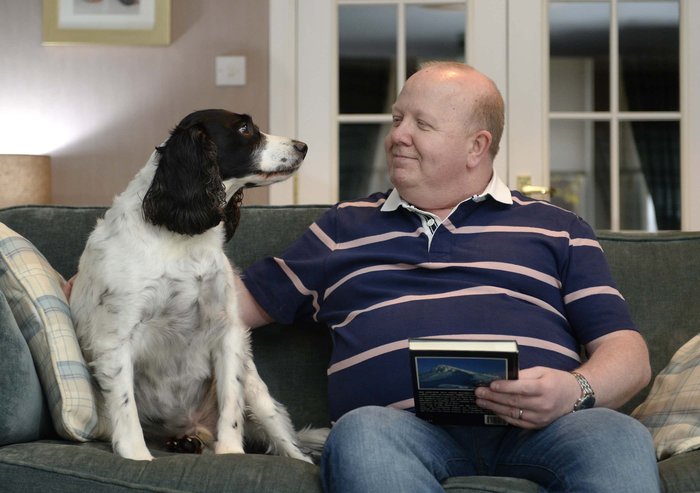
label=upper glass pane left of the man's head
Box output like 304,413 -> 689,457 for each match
338,5 -> 396,113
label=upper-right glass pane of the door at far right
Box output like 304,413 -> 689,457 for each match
618,0 -> 680,111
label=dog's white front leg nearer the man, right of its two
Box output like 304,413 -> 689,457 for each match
213,327 -> 248,454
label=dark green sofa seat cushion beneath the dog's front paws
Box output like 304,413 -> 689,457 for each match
0,441 -> 321,493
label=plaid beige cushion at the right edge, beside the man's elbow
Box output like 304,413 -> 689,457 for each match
632,334 -> 700,460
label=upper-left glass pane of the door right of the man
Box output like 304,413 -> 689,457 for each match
549,1 -> 610,111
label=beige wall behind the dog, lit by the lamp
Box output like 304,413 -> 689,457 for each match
0,0 -> 268,205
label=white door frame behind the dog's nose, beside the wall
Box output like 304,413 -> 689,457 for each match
269,0 -> 338,204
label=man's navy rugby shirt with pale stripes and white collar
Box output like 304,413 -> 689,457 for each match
243,177 -> 634,420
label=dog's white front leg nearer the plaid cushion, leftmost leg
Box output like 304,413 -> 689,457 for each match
92,346 -> 153,460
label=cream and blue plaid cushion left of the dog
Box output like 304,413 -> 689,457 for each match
0,223 -> 105,441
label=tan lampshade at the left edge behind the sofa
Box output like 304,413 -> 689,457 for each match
0,154 -> 51,207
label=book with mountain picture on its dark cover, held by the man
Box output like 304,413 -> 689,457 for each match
408,338 -> 518,425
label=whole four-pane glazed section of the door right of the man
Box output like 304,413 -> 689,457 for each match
549,0 -> 681,231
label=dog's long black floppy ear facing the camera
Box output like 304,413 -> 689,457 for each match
143,120 -> 226,235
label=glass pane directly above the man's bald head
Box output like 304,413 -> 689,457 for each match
406,2 -> 466,77
